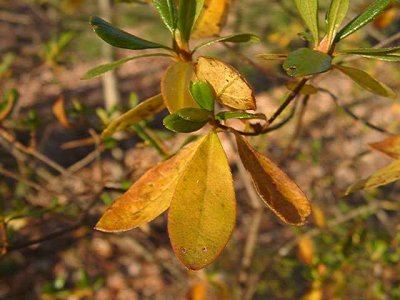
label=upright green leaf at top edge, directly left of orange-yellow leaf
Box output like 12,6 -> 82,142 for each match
178,0 -> 204,42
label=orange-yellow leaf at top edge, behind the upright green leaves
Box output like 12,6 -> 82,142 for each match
192,0 -> 231,38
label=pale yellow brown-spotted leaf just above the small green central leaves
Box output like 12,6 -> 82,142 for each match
195,57 -> 256,110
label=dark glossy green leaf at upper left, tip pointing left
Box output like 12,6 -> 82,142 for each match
90,17 -> 170,50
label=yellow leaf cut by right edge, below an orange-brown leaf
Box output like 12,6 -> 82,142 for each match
345,159 -> 400,195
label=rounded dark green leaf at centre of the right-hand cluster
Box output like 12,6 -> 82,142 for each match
283,48 -> 332,77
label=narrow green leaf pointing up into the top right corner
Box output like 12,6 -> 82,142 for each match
335,0 -> 391,42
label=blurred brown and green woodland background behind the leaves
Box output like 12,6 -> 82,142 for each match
0,0 -> 400,300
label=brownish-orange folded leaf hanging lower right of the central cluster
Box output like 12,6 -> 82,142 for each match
236,134 -> 311,225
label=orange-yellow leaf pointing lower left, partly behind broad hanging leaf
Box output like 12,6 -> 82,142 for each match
95,139 -> 203,232
